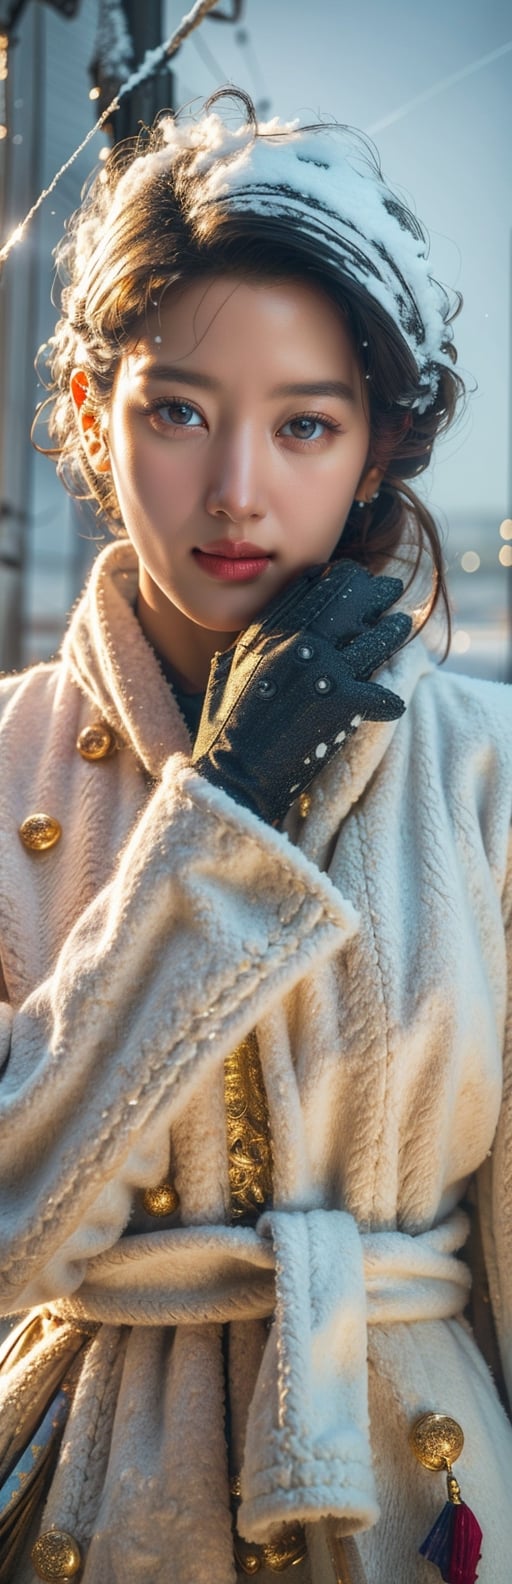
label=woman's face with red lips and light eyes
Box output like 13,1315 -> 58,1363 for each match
86,277 -> 374,686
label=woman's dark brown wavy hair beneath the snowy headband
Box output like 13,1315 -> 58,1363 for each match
40,89 -> 463,643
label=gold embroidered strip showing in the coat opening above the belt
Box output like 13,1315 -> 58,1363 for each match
224,1033 -> 273,1221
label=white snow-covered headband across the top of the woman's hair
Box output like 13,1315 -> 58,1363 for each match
114,112 -> 452,413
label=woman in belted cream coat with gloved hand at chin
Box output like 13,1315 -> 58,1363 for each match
0,83 -> 512,1584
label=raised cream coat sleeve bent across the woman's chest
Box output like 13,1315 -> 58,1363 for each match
0,756 -> 357,1315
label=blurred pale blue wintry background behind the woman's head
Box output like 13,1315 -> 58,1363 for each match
0,0 -> 512,681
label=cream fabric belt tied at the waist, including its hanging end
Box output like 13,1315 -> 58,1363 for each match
52,1210 -> 471,1540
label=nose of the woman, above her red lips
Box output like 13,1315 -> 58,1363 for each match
204,423 -> 266,527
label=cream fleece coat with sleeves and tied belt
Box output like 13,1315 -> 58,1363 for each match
0,545 -> 512,1584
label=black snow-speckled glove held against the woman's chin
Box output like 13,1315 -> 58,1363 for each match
192,561 -> 412,825
